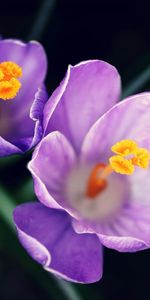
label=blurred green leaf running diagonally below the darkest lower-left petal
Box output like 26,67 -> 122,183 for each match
0,187 -> 81,300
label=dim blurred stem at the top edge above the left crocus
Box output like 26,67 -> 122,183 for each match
27,0 -> 56,40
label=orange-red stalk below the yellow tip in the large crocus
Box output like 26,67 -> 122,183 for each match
86,163 -> 112,199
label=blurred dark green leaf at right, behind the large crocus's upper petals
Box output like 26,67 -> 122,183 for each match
122,67 -> 150,99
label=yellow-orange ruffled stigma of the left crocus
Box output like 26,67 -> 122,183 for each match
0,61 -> 22,100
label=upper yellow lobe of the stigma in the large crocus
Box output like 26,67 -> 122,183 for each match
111,140 -> 138,156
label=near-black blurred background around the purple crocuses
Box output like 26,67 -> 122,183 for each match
0,0 -> 150,300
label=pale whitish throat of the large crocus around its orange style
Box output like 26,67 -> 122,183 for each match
65,164 -> 126,222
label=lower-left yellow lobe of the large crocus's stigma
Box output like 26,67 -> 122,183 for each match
109,155 -> 134,175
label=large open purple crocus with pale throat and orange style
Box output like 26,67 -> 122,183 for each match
14,60 -> 150,283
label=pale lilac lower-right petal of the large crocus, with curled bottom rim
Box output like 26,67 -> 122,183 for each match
73,165 -> 150,252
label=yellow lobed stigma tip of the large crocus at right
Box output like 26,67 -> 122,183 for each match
109,140 -> 150,175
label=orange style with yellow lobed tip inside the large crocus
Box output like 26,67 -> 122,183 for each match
85,140 -> 150,199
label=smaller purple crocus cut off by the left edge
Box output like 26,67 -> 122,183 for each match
0,39 -> 47,157
